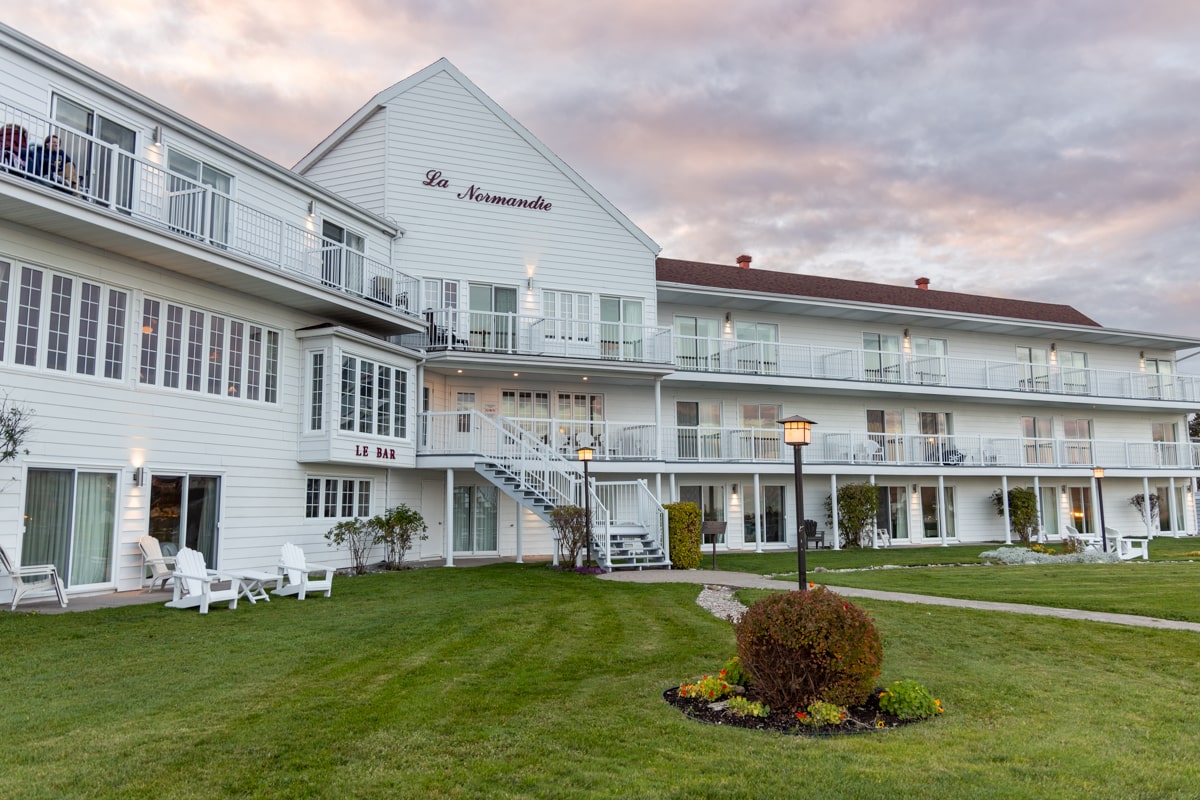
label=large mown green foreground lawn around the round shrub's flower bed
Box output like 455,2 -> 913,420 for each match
0,563 -> 1200,800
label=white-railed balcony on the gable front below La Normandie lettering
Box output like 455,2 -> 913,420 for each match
401,308 -> 671,365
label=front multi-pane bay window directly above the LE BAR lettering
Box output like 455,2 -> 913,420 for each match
338,355 -> 408,439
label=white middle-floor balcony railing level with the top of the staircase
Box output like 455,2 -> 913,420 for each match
419,411 -> 1200,470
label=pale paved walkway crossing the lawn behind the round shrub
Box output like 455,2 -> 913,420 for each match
598,570 -> 1200,633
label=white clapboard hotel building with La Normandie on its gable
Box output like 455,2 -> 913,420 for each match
0,26 -> 1200,600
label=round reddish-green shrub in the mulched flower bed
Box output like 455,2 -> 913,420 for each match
734,587 -> 883,711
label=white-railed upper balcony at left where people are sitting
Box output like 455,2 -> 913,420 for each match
0,103 -> 418,319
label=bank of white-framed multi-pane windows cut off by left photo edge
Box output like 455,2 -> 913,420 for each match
0,263 -> 128,380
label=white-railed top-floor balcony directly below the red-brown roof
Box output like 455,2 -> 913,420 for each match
674,336 -> 1200,402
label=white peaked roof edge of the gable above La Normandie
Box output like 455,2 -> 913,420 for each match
294,58 -> 662,254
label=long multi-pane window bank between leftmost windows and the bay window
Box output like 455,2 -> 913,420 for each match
140,297 -> 280,403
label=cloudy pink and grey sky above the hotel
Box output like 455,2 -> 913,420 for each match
9,0 -> 1200,340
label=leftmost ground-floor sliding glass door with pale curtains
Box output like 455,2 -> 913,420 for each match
20,469 -> 118,587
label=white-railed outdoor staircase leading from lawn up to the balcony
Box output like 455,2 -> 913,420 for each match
473,411 -> 671,571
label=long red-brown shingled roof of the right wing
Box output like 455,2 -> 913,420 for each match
658,258 -> 1100,327
